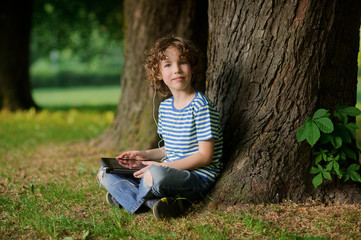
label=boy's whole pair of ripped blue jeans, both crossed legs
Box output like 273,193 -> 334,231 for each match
99,165 -> 213,213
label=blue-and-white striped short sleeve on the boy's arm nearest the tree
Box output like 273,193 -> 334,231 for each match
195,105 -> 219,141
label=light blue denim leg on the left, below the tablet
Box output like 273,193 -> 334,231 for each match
99,167 -> 150,213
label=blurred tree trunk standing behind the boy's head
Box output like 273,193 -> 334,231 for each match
95,0 -> 208,149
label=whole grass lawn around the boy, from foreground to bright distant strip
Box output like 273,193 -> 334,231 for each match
0,88 -> 361,240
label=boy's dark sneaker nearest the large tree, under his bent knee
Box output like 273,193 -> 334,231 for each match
153,197 -> 184,220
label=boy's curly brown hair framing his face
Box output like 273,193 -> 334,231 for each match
145,36 -> 202,96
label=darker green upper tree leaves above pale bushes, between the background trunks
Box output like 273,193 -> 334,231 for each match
31,0 -> 123,62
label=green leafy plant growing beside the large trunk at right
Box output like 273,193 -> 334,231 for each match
297,105 -> 361,188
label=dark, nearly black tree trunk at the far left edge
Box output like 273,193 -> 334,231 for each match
0,0 -> 36,111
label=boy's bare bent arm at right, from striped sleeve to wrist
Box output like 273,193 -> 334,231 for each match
161,138 -> 214,170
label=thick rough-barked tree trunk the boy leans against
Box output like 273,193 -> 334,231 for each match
207,0 -> 361,203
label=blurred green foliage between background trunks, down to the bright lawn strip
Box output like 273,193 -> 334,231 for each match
30,0 -> 123,88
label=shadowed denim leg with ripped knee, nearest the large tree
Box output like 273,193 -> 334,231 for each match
149,165 -> 213,201
